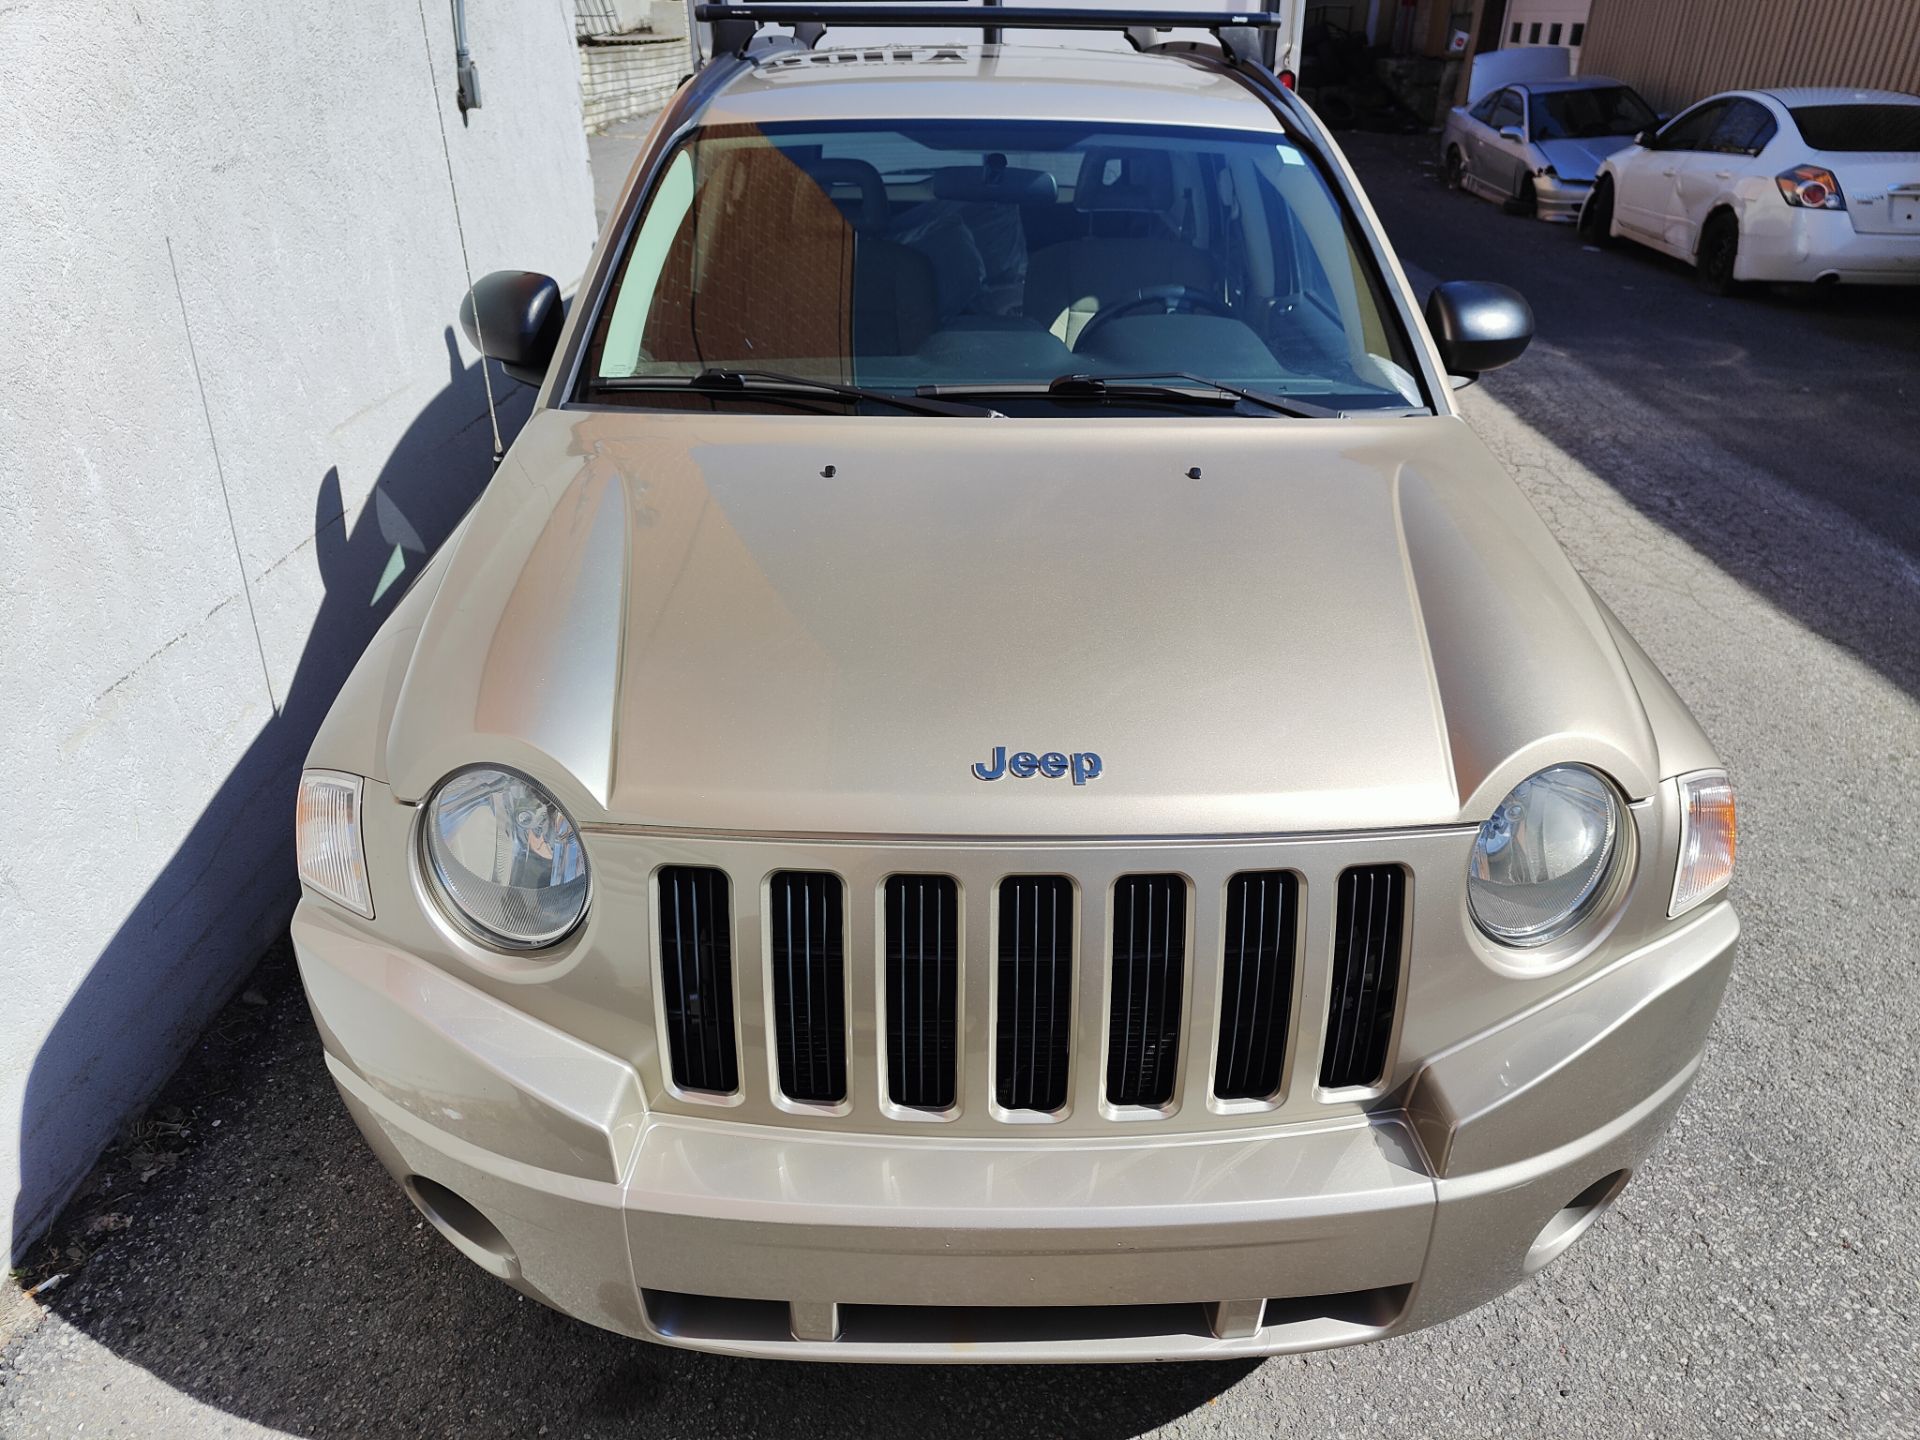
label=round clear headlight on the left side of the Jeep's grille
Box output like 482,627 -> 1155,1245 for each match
426,766 -> 588,950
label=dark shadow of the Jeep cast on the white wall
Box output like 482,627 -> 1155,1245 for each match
13,326 -> 532,1248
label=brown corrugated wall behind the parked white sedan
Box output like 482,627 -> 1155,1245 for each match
1580,0 -> 1920,111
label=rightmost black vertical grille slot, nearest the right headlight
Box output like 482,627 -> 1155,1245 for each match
1321,866 -> 1407,1089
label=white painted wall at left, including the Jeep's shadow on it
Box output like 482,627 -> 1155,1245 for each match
0,0 -> 593,1254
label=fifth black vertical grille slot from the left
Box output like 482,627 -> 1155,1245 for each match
1106,876 -> 1187,1106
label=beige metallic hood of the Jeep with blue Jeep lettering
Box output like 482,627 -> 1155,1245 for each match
388,409 -> 1657,835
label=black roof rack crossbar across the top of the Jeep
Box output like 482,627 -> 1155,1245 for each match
693,0 -> 1286,61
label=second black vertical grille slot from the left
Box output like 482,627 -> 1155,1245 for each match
766,870 -> 847,1104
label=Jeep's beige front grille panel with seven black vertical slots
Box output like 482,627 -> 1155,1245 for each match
652,844 -> 1420,1140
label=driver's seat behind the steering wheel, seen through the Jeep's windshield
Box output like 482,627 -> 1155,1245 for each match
1025,146 -> 1219,346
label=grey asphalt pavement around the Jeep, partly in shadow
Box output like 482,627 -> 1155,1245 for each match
0,136 -> 1920,1440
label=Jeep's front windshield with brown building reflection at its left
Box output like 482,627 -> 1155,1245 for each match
584,121 -> 1425,415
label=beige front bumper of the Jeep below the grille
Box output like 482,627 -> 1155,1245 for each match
294,899 -> 1738,1361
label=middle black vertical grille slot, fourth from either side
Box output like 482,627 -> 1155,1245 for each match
995,876 -> 1073,1110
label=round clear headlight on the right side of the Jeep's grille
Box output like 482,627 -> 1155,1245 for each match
1467,764 -> 1622,947
